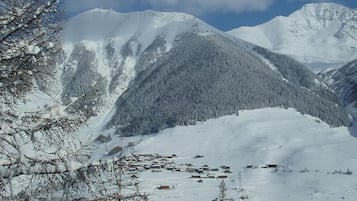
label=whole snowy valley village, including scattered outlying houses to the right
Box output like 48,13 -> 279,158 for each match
95,153 -> 352,200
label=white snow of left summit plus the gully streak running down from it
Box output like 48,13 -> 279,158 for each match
60,8 -> 218,108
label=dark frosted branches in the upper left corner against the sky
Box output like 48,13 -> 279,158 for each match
0,0 -> 61,97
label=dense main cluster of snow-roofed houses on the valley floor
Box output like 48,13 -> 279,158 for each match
118,154 -> 232,182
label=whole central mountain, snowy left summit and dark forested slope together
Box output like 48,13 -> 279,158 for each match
50,9 -> 350,135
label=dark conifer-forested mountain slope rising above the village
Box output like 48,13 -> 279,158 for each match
107,34 -> 349,135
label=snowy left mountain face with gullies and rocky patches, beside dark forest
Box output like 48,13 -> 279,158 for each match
56,9 -> 215,116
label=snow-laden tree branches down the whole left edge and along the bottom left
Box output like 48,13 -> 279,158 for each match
0,0 -> 147,200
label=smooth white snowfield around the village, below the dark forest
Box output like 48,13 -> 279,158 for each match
102,108 -> 357,201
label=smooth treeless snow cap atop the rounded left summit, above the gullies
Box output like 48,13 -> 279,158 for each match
63,8 -> 217,60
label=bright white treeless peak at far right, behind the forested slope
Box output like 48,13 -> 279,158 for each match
228,3 -> 357,72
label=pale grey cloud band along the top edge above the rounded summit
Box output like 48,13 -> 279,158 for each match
61,0 -> 277,15
